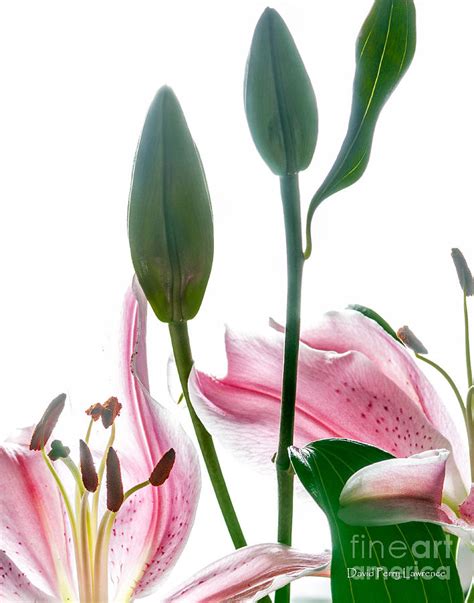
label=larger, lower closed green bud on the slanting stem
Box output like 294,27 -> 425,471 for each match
128,86 -> 214,322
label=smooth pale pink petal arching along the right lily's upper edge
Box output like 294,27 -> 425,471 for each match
301,310 -> 470,502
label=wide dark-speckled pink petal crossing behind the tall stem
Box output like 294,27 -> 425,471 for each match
189,331 -> 466,501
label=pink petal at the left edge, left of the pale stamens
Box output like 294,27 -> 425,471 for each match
0,428 -> 73,601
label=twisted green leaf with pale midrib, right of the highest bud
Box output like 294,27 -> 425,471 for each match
305,0 -> 416,257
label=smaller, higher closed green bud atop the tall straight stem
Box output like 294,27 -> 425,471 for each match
245,8 -> 318,176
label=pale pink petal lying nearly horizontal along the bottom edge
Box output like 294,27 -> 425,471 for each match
163,544 -> 331,603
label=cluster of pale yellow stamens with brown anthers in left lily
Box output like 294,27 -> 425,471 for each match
30,395 -> 175,603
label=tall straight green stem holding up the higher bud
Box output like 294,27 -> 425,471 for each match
275,174 -> 304,603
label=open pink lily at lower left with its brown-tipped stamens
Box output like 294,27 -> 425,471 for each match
0,284 -> 330,603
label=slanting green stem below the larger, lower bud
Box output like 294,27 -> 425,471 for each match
169,321 -> 247,549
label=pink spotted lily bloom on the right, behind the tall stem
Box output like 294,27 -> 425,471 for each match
190,310 -> 473,537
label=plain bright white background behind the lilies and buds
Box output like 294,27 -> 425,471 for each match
0,0 -> 474,600
